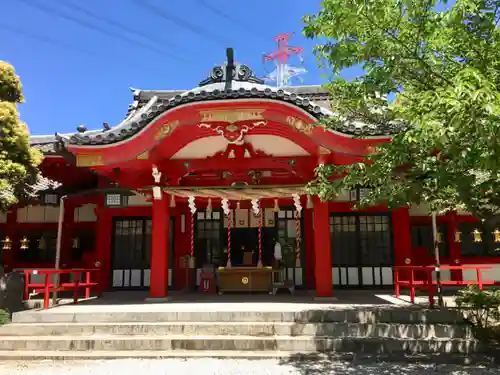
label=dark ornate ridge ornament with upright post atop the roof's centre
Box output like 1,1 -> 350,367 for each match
199,48 -> 264,90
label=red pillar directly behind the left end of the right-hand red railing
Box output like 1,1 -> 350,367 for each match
392,207 -> 415,280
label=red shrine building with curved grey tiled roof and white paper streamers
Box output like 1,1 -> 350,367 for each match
0,53 -> 500,298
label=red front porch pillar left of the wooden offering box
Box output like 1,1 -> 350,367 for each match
149,194 -> 170,298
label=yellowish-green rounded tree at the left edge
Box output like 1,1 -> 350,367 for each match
0,61 -> 41,211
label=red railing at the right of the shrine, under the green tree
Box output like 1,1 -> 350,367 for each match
394,266 -> 495,307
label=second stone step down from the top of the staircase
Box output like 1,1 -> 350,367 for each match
0,322 -> 473,339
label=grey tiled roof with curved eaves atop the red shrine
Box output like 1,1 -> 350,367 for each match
31,60 -> 402,153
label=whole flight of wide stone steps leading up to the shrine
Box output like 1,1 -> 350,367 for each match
0,304 -> 488,360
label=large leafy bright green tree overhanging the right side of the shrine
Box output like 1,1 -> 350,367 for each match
304,0 -> 500,223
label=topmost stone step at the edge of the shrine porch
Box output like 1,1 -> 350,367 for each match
12,308 -> 463,324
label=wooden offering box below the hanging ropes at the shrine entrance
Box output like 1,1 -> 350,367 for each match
217,267 -> 273,294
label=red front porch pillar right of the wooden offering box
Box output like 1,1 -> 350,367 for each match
313,197 -> 332,297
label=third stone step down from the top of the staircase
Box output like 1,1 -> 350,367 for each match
0,335 -> 481,354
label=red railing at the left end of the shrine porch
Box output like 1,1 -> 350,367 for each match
22,269 -> 99,310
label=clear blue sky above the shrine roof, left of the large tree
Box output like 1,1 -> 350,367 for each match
0,0 -> 356,134
